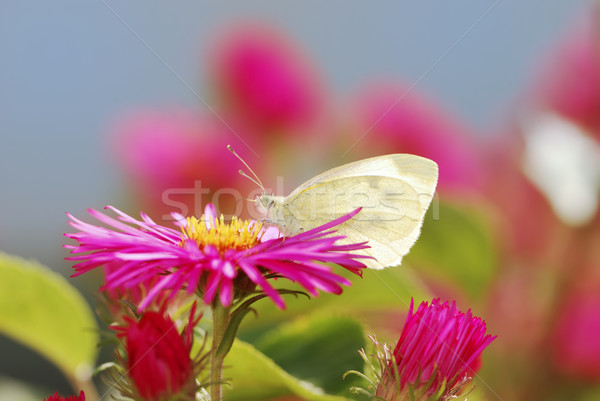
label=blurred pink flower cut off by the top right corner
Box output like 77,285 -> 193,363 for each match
534,5 -> 600,140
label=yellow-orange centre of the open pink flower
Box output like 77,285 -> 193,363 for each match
181,215 -> 262,253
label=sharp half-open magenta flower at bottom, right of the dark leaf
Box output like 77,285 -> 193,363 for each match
376,298 -> 496,401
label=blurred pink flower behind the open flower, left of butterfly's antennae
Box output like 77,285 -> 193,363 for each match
111,110 -> 260,216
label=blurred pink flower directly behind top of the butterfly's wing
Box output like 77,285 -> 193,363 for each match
346,83 -> 481,191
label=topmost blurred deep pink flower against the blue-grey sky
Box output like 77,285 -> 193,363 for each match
208,23 -> 325,137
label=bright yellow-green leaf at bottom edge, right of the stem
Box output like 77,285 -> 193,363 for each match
223,340 -> 356,401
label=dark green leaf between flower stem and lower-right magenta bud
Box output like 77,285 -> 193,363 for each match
256,315 -> 366,395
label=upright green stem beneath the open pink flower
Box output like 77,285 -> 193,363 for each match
210,301 -> 230,401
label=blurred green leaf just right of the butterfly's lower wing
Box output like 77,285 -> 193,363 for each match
405,203 -> 498,299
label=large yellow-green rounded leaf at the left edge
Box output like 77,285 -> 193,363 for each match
0,253 -> 98,382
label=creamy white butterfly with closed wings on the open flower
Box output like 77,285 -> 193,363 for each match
257,154 -> 438,269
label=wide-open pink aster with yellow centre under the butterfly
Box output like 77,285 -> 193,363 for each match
65,205 -> 368,309
